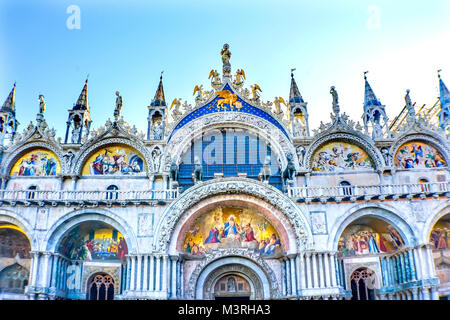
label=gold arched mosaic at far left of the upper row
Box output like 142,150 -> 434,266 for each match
10,148 -> 61,177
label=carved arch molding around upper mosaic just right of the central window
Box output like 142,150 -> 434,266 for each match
303,132 -> 384,171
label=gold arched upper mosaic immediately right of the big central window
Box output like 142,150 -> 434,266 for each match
311,141 -> 375,172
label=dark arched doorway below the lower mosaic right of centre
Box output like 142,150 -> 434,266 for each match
350,268 -> 375,300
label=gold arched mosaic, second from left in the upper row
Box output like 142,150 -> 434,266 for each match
82,144 -> 146,175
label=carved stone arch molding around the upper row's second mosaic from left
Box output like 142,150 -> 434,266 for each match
72,138 -> 153,175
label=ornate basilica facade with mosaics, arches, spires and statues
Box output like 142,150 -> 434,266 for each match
0,45 -> 450,300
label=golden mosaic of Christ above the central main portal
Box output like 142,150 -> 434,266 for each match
183,207 -> 282,256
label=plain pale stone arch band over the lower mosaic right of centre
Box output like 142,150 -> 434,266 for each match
327,204 -> 418,251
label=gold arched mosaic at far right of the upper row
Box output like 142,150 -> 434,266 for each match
394,141 -> 447,169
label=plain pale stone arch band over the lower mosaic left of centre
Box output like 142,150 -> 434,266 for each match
42,208 -> 138,253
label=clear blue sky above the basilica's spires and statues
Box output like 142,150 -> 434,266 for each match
0,0 -> 450,137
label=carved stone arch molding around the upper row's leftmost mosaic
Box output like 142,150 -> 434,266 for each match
1,141 -> 66,175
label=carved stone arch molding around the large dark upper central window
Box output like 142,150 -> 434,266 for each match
164,111 -> 300,171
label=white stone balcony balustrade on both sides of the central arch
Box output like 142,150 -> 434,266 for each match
0,178 -> 450,206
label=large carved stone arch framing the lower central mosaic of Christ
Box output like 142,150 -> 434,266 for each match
154,178 -> 312,254
